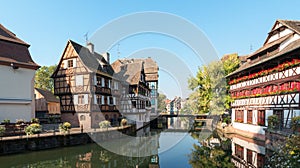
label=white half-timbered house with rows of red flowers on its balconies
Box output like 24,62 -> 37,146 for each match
227,20 -> 300,137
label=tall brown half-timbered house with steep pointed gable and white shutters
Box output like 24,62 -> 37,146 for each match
52,40 -> 120,129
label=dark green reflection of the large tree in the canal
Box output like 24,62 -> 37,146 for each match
189,132 -> 234,168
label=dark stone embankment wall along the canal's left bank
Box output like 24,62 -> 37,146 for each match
0,125 -> 135,155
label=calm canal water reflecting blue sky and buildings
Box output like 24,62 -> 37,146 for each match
0,118 -> 260,168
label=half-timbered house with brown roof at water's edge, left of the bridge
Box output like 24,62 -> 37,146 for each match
112,59 -> 151,128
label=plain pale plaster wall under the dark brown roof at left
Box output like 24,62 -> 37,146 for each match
0,66 -> 35,122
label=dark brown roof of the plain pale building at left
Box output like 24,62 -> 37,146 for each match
0,24 -> 40,69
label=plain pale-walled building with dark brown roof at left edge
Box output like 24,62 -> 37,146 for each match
0,24 -> 39,122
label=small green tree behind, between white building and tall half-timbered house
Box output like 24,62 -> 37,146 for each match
34,65 -> 56,92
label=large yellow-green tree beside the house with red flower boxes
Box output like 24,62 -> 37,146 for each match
181,54 -> 240,115
